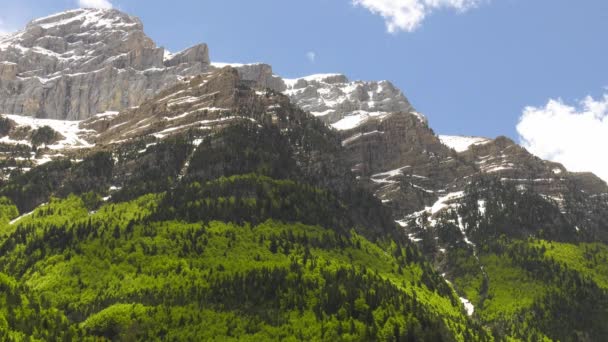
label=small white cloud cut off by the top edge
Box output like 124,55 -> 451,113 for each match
352,0 -> 486,33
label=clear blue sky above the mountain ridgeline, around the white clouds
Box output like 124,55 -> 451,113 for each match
0,0 -> 608,180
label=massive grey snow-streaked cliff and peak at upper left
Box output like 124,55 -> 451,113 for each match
0,9 -> 209,120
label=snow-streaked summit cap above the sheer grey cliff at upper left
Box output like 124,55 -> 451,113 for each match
0,9 -> 150,63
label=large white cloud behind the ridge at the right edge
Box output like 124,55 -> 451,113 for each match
517,94 -> 608,182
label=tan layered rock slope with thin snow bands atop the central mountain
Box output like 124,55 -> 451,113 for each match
81,67 -> 254,145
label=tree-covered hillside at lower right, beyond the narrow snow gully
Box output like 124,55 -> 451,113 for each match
422,178 -> 608,341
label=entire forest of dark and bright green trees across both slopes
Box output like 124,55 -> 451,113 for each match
0,101 -> 608,342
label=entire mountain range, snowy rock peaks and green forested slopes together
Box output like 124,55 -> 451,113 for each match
0,9 -> 608,341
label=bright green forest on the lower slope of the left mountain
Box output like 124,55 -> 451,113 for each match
0,191 -> 491,341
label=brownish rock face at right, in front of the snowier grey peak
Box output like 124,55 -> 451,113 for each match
342,113 -> 608,241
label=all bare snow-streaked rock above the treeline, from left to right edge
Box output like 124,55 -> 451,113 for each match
0,9 -> 608,244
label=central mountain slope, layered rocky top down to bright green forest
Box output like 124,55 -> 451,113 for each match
0,58 -> 491,341
